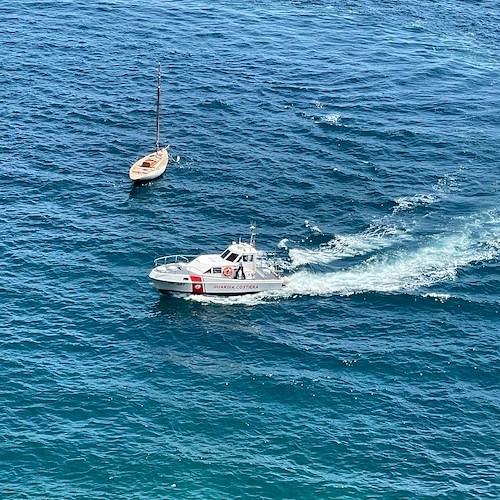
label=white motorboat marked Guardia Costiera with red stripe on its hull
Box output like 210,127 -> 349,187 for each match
149,226 -> 285,295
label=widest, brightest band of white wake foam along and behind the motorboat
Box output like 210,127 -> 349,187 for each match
181,213 -> 500,305
